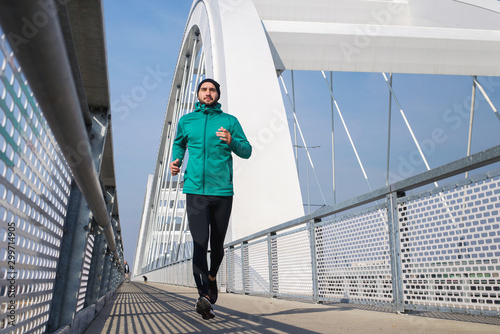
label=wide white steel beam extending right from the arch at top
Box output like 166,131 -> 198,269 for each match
253,0 -> 500,76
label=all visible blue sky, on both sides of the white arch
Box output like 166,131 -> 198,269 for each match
104,0 -> 500,263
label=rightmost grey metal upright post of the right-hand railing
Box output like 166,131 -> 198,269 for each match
387,192 -> 404,312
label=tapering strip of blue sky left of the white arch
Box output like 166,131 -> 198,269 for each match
104,0 -> 191,264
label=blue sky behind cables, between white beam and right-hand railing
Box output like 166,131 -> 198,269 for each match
285,72 -> 500,212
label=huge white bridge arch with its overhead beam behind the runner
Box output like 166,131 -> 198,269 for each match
135,0 -> 500,273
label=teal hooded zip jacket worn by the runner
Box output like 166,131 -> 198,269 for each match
172,102 -> 252,196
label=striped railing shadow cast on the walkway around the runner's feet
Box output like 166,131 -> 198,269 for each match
85,282 -> 318,334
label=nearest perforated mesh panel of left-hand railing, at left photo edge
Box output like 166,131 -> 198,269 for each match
0,35 -> 71,333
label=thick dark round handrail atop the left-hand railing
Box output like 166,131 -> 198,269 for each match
0,0 -> 121,267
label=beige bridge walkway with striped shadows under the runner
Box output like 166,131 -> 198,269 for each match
85,282 -> 500,334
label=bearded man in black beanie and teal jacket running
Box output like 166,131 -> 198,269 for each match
170,79 -> 252,319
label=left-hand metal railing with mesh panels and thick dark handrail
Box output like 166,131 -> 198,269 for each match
0,1 -> 124,333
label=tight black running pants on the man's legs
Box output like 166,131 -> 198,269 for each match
186,194 -> 233,296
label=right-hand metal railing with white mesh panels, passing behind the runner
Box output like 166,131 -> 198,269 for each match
141,146 -> 500,316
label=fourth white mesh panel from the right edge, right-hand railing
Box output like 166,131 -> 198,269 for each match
245,239 -> 269,293
